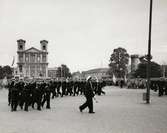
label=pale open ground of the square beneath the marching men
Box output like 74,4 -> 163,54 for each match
0,87 -> 167,133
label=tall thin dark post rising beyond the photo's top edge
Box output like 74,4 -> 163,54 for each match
146,0 -> 153,103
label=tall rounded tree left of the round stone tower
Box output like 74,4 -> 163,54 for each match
109,47 -> 129,78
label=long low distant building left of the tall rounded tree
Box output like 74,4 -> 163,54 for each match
82,68 -> 111,79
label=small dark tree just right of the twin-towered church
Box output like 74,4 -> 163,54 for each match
57,64 -> 71,78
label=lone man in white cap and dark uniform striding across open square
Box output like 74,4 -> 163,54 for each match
79,76 -> 95,113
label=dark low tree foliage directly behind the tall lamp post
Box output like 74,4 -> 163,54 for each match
133,61 -> 162,78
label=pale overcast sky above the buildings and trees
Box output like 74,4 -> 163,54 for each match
0,0 -> 167,72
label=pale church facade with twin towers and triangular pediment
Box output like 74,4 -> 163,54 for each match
16,39 -> 48,78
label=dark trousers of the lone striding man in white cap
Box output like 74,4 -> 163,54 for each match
80,97 -> 93,112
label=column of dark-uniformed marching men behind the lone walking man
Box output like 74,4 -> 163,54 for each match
8,79 -> 106,111
